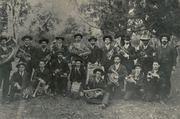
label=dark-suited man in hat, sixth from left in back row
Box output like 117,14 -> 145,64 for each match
88,37 -> 102,64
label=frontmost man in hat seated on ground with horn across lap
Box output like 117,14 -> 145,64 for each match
83,68 -> 106,104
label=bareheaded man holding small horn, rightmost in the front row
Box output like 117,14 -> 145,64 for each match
144,61 -> 164,101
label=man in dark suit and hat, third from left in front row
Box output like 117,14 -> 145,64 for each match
51,51 -> 69,96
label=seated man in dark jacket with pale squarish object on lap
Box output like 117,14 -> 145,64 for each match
70,59 -> 86,94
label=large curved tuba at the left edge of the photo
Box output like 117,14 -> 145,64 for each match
0,38 -> 18,65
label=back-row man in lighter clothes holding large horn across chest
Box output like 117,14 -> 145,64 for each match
69,33 -> 91,60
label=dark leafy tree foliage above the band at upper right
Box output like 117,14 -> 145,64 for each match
80,0 -> 180,37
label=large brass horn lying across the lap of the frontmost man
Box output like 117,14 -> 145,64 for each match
83,88 -> 105,99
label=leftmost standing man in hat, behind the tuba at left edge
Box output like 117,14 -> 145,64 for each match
0,36 -> 12,103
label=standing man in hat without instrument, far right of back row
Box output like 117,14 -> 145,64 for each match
157,34 -> 177,99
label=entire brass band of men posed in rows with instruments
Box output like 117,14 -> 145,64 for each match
0,33 -> 177,108
